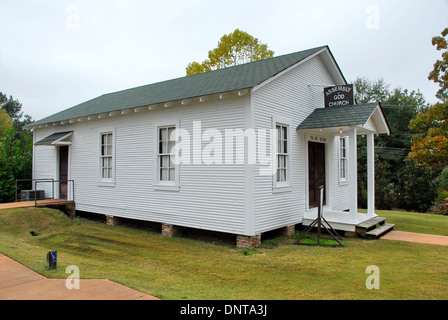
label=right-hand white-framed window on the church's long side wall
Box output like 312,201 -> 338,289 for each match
158,126 -> 176,182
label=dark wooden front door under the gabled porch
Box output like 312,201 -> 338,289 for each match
308,141 -> 326,208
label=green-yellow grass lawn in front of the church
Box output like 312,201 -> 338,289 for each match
0,208 -> 448,300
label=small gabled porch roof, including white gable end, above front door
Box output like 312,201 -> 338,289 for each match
297,103 -> 390,135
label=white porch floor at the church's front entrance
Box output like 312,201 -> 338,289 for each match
302,207 -> 376,232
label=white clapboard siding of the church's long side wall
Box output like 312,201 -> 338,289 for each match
35,95 -> 250,234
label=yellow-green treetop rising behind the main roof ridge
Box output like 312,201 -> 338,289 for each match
186,29 -> 274,76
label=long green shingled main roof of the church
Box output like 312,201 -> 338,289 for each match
29,46 -> 328,126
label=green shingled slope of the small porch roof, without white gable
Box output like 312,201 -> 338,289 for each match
297,103 -> 381,130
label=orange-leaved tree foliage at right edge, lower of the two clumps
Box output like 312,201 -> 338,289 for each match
409,101 -> 448,168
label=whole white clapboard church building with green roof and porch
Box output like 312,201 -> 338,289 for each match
28,46 -> 390,247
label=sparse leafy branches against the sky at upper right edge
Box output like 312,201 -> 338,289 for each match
428,28 -> 448,102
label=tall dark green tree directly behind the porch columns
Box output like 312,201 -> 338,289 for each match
353,77 -> 428,209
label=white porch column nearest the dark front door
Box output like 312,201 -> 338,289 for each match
348,127 -> 358,221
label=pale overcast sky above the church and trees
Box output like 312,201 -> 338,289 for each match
0,0 -> 448,120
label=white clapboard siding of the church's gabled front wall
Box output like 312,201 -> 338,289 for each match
253,56 -> 349,234
